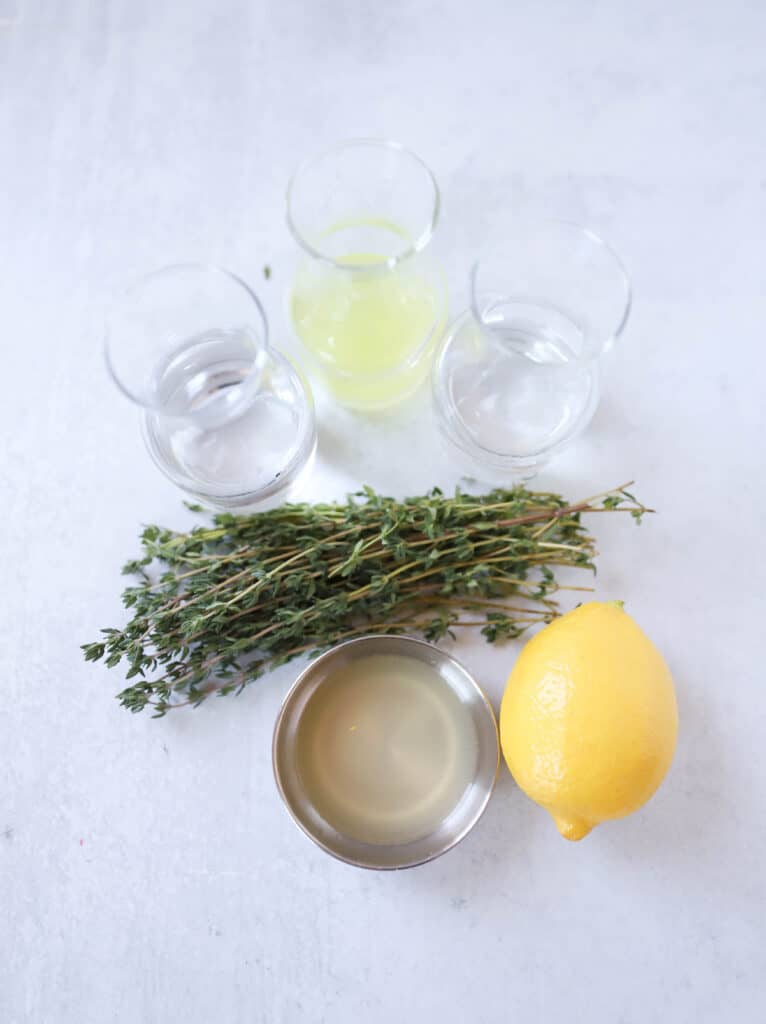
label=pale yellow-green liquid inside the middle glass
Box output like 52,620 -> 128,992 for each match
291,230 -> 445,409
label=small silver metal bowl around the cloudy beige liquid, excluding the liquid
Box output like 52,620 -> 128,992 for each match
272,636 -> 500,870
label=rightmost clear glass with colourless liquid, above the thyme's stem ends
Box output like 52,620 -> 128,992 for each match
432,221 -> 631,480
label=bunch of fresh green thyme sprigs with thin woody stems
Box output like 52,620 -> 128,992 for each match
83,487 -> 650,717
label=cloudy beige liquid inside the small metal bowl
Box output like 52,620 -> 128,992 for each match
297,654 -> 478,845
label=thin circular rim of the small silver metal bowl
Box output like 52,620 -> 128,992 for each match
271,633 -> 502,871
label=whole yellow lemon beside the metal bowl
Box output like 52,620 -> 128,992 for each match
500,601 -> 678,840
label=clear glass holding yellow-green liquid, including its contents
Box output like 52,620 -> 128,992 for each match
287,139 -> 446,410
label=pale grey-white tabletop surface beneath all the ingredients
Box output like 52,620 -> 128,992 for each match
0,0 -> 766,1024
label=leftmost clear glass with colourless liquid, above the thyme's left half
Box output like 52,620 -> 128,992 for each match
104,264 -> 316,509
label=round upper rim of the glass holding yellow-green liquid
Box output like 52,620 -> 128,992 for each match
285,136 -> 441,272
